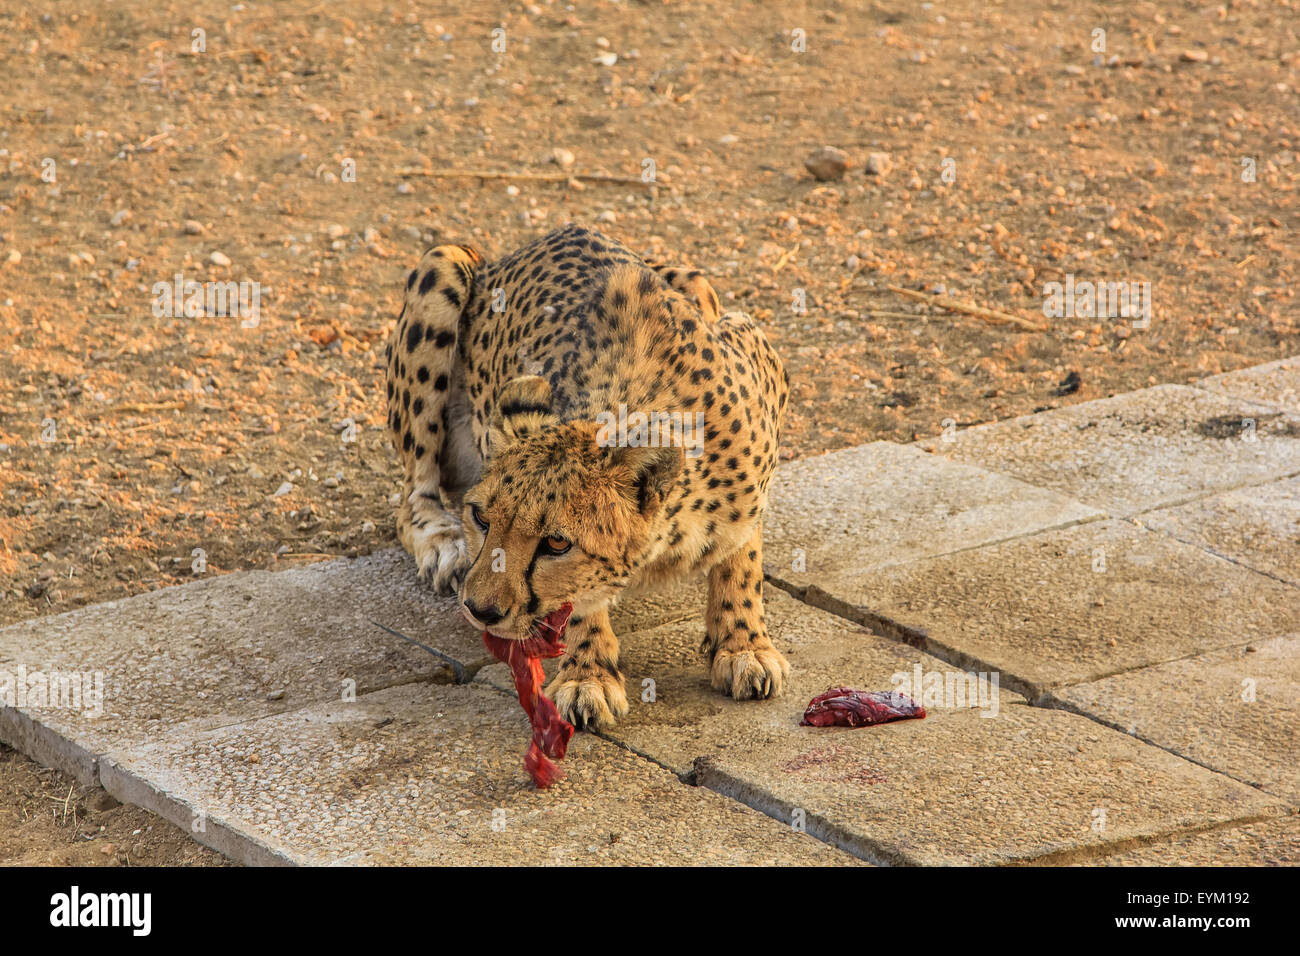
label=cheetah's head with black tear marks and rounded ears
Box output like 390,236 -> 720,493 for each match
460,376 -> 684,639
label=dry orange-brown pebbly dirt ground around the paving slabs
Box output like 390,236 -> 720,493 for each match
0,0 -> 1300,864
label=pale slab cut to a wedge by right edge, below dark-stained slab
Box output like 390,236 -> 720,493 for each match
1140,477 -> 1300,587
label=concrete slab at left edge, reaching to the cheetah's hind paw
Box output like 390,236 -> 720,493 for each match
0,551 -> 486,783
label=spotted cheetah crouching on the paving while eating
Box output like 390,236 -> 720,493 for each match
386,224 -> 789,730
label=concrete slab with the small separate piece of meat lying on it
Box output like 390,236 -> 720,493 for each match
480,588 -> 1283,864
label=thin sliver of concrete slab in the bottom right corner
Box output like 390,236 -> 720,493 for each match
1089,814 -> 1300,866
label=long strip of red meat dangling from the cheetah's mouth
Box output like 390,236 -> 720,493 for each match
484,604 -> 573,790
